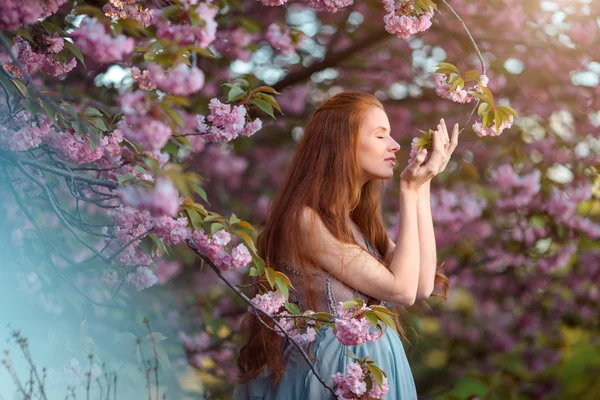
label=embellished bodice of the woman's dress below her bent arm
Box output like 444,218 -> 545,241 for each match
283,236 -> 382,315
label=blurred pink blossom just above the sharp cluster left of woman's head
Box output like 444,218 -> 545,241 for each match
148,63 -> 204,96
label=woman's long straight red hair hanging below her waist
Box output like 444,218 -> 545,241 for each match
237,92 -> 448,385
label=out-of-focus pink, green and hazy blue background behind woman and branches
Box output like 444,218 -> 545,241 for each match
0,0 -> 600,400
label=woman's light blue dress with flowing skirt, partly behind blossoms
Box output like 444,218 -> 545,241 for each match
233,239 -> 417,400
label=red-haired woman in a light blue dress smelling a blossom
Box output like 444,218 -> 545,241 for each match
233,92 -> 458,400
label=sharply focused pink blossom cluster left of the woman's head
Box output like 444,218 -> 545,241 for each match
197,98 -> 262,142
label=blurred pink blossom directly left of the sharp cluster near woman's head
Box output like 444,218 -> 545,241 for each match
119,115 -> 173,150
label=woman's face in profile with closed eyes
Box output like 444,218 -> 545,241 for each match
358,107 -> 400,182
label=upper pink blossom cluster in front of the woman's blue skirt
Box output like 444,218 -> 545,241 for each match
333,302 -> 381,346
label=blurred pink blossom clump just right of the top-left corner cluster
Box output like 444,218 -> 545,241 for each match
71,18 -> 135,63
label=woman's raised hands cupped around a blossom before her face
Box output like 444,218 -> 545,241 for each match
400,118 -> 459,191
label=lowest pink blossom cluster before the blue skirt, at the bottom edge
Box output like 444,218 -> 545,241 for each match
331,362 -> 390,400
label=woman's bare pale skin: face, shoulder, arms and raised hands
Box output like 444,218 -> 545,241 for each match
300,107 -> 459,306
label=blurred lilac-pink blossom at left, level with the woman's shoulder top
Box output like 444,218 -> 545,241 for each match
117,178 -> 179,217
